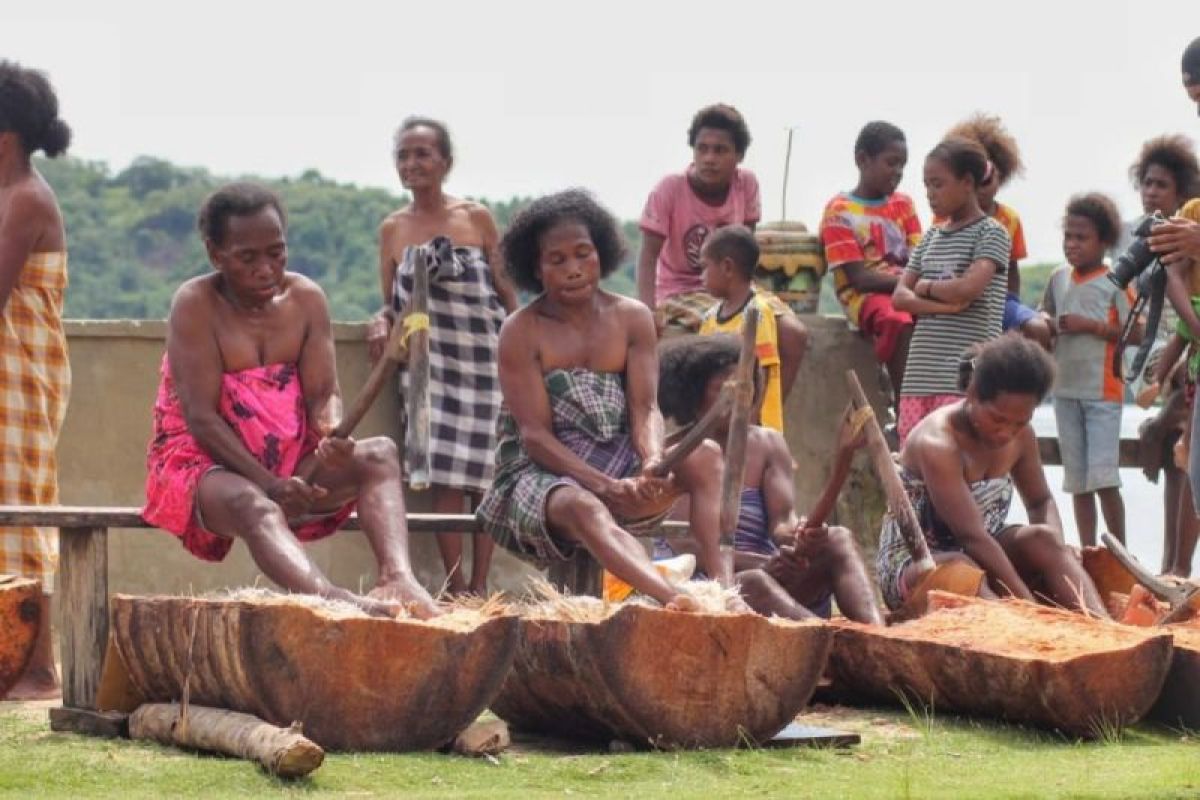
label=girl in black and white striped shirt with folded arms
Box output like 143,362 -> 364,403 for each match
892,137 -> 1010,445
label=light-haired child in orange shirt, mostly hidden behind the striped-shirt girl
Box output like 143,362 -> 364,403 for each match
934,114 -> 1051,350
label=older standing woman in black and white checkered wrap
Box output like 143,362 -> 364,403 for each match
367,116 -> 517,595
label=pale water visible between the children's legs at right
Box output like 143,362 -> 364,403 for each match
1008,404 -> 1163,572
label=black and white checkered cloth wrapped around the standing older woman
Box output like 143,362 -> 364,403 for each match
391,236 -> 504,492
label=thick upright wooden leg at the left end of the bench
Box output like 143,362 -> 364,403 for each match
59,528 -> 108,710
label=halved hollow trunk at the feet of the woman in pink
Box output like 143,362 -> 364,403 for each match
112,590 -> 517,751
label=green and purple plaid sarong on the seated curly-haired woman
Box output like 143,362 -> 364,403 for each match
475,368 -> 666,567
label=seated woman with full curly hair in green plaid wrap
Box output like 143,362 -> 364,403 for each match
476,191 -> 733,609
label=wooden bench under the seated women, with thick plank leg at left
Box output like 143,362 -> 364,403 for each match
0,506 -> 686,735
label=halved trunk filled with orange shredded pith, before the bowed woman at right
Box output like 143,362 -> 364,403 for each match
829,593 -> 1171,738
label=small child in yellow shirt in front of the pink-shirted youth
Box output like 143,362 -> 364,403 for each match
700,225 -> 806,433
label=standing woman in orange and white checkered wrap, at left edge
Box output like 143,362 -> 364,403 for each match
0,61 -> 71,700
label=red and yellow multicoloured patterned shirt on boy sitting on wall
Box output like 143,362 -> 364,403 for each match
821,192 -> 920,325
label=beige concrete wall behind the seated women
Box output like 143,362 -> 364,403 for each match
59,317 -> 881,593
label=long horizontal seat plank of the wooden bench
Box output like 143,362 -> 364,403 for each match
0,506 -> 688,536
